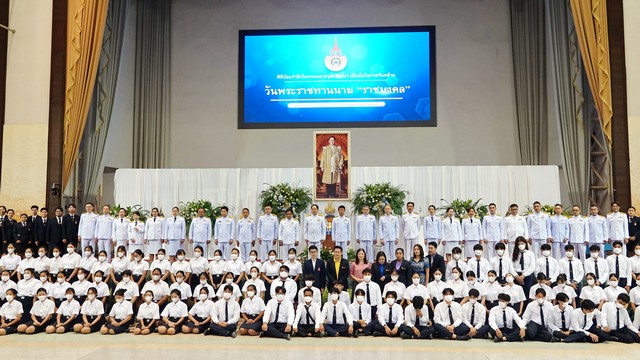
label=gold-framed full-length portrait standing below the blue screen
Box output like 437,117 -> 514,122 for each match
313,131 -> 351,201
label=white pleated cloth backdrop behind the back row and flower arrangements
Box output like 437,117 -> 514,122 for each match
114,166 -> 560,256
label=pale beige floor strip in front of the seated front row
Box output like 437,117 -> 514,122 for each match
0,334 -> 640,360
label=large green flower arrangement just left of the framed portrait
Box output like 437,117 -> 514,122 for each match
260,183 -> 313,219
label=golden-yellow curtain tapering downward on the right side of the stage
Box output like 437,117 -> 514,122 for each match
570,0 -> 613,146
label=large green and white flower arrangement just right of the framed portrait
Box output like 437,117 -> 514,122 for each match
351,182 -> 409,217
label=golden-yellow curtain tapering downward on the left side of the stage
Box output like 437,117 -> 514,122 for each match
62,0 -> 109,187
